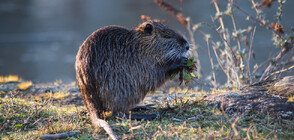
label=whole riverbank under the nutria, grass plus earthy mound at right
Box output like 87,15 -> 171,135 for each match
0,78 -> 294,139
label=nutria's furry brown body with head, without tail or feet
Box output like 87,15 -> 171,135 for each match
75,21 -> 189,139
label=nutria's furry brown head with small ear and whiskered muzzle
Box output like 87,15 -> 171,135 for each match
133,21 -> 189,63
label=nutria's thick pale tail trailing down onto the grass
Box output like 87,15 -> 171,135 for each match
90,113 -> 117,140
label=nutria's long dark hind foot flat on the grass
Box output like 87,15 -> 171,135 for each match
114,113 -> 160,121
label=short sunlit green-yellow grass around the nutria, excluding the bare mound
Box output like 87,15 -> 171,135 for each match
0,89 -> 294,139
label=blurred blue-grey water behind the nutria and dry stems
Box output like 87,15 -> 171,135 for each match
0,0 -> 294,82
